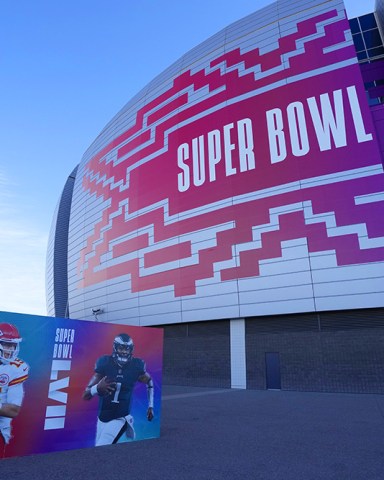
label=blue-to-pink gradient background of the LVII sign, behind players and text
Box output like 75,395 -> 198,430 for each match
0,312 -> 163,457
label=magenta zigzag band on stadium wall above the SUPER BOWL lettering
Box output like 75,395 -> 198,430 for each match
83,7 -> 356,191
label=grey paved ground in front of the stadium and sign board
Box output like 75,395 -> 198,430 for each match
0,386 -> 384,480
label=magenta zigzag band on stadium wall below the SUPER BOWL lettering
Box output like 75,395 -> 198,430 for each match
78,172 -> 384,296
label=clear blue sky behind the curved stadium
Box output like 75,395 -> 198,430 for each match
0,0 -> 374,315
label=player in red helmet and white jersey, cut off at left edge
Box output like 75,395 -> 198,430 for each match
0,323 -> 29,458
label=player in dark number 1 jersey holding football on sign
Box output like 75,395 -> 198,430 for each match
83,333 -> 154,446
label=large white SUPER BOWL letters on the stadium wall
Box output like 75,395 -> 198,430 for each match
177,86 -> 372,192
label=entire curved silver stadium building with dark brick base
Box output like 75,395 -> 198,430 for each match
47,0 -> 384,393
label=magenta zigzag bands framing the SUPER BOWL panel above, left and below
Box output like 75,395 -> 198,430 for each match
78,11 -> 384,296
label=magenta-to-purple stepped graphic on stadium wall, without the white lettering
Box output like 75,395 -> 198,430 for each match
78,10 -> 384,297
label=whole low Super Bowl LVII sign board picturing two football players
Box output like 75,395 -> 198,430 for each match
0,312 -> 163,458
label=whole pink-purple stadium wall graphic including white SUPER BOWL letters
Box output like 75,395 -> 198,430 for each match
69,0 -> 384,322
